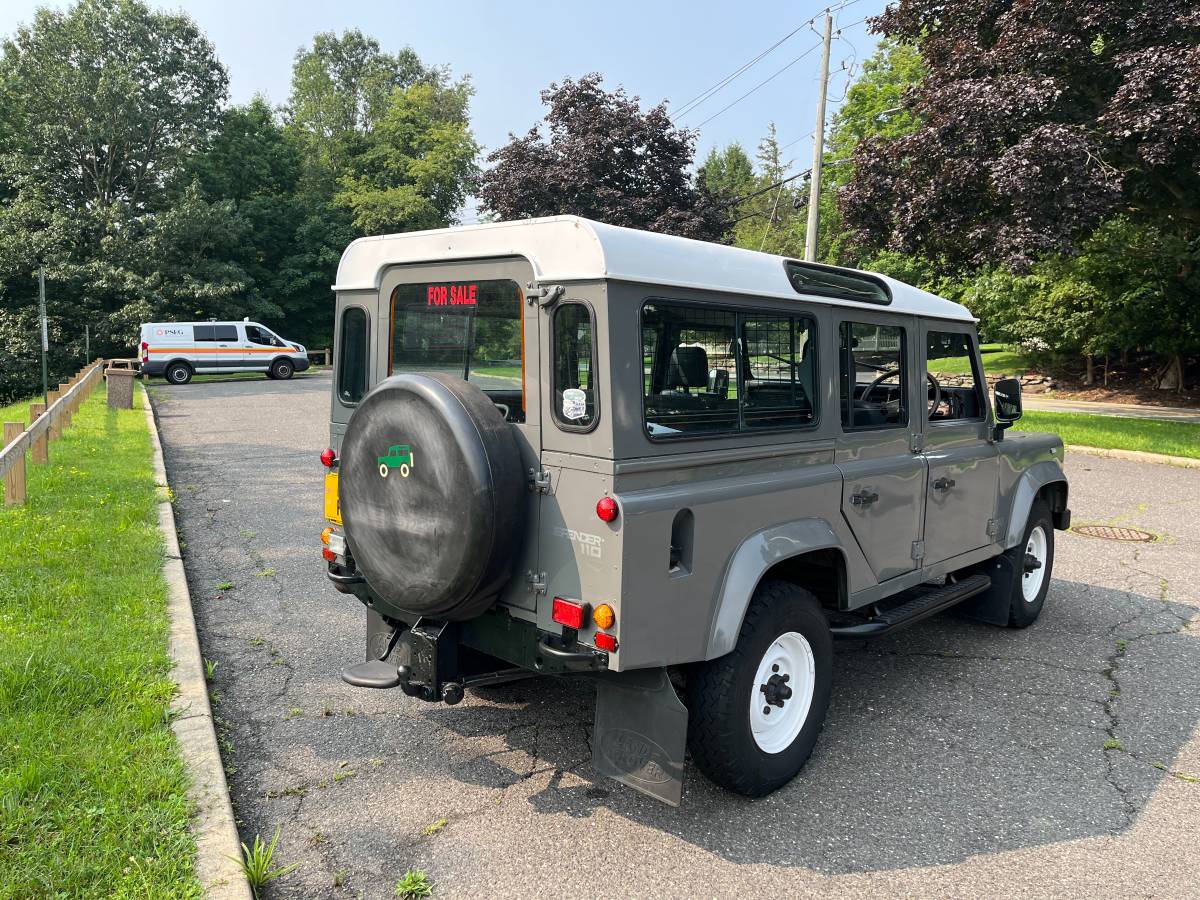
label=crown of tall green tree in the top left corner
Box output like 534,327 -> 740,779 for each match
0,0 -> 227,214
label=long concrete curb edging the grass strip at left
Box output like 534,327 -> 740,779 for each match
142,390 -> 253,900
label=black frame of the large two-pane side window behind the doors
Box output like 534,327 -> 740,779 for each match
636,296 -> 823,443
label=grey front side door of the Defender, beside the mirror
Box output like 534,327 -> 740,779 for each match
920,322 -> 1000,564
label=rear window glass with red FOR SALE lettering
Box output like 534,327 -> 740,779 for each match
391,278 -> 523,394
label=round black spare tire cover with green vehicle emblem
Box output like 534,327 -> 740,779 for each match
338,374 -> 528,620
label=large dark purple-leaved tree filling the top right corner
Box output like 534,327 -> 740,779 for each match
840,0 -> 1200,386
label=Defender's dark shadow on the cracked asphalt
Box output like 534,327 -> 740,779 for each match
424,581 -> 1200,874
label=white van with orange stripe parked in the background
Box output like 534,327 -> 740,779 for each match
139,319 -> 308,384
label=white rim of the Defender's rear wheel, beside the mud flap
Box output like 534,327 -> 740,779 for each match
750,631 -> 817,754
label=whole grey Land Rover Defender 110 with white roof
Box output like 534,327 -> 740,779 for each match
322,217 -> 1070,804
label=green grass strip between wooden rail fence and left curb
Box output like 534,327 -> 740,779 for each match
0,391 -> 200,898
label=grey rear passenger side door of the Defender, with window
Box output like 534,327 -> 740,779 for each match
836,311 -> 925,582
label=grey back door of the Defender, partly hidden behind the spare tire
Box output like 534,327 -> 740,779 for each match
373,259 -> 541,619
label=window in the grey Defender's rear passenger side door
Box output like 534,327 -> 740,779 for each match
839,322 -> 908,428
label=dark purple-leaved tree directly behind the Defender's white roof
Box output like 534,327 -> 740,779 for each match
479,73 -> 725,240
